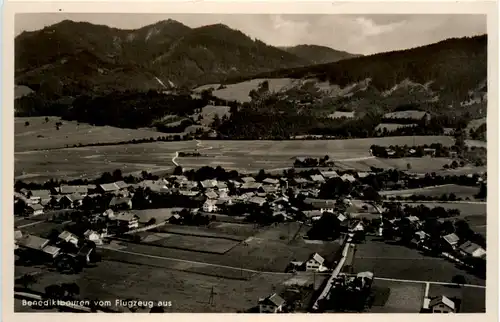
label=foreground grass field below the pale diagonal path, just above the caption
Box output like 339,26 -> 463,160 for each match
14,261 -> 288,313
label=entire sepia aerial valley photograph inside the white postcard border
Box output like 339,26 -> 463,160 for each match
4,4 -> 498,319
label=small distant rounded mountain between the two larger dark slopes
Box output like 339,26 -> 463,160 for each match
280,45 -> 361,64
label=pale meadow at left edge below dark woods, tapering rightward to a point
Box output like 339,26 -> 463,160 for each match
14,116 -> 165,152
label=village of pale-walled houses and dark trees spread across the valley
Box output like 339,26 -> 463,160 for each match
14,157 -> 486,313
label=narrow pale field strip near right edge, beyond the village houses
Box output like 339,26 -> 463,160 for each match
380,184 -> 479,199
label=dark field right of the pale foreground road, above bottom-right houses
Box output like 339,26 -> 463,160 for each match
353,237 -> 485,285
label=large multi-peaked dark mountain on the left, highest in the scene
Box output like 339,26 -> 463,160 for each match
15,20 -> 312,93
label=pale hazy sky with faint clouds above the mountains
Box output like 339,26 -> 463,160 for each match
15,13 -> 487,54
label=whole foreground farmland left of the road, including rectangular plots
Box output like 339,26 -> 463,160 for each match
16,222 -> 340,312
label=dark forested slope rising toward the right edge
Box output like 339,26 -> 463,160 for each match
226,35 -> 488,106
